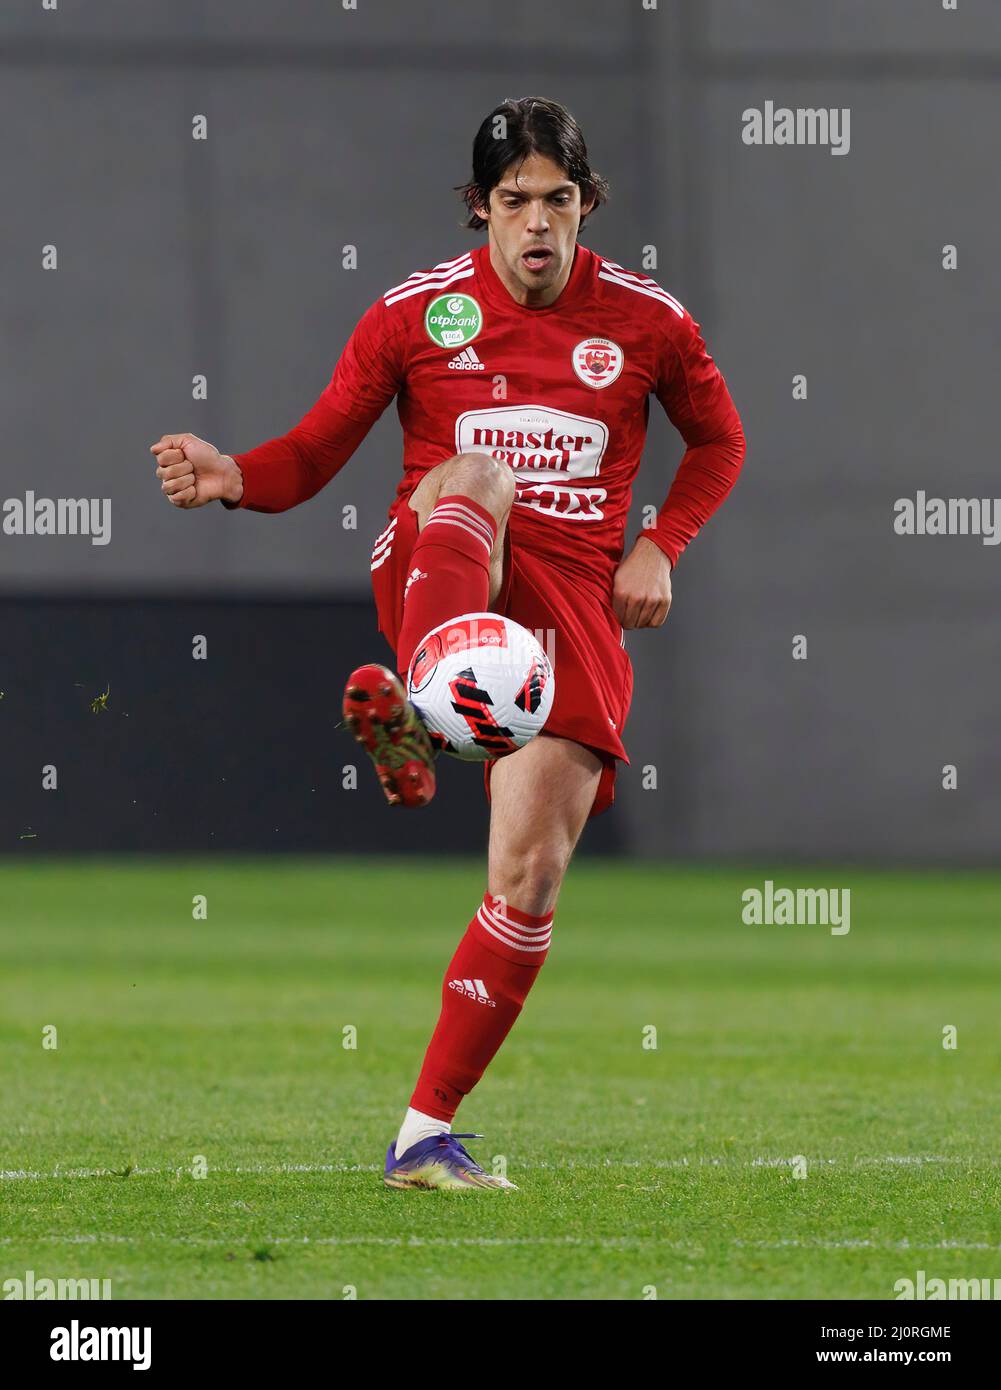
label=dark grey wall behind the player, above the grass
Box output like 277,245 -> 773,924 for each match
0,0 -> 1001,862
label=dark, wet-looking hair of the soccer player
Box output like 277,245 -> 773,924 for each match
457,96 -> 608,232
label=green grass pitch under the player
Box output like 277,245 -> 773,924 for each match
0,859 -> 1001,1298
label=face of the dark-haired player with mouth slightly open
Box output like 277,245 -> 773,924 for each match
482,154 -> 591,304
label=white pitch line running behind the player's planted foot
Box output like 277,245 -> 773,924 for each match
0,1154 -> 998,1183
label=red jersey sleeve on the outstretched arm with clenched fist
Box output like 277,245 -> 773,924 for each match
234,299 -> 403,512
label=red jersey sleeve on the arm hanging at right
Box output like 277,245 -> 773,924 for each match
641,310 -> 745,566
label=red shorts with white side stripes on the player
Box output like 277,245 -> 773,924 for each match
371,498 -> 633,816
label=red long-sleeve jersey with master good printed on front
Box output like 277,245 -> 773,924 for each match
235,245 -> 744,587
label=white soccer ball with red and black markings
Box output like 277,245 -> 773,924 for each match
407,613 -> 556,762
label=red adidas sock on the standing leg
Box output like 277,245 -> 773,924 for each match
410,894 -> 552,1120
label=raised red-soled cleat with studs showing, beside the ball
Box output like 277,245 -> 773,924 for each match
343,663 -> 435,806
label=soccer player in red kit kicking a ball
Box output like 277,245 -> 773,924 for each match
152,97 -> 744,1188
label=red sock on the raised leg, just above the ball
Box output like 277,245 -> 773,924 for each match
396,493 -> 496,671
